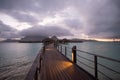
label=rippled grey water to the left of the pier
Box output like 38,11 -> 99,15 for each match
0,43 -> 42,80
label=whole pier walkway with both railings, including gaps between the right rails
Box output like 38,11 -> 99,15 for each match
25,44 -> 120,80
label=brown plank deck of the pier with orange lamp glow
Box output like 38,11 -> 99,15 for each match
39,44 -> 95,80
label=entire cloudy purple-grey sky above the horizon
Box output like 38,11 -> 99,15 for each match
0,0 -> 120,38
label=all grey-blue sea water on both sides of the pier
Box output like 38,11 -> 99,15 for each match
0,42 -> 120,80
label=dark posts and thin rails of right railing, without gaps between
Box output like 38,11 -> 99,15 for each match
58,45 -> 120,80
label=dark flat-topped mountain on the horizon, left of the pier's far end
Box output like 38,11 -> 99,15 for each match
19,36 -> 47,42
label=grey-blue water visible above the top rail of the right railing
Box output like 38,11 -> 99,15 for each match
67,42 -> 120,60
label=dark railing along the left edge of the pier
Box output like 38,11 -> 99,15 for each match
25,46 -> 45,80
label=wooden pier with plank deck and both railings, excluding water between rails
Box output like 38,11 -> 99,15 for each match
25,44 -> 120,80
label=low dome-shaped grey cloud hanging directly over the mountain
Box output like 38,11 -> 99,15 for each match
20,26 -> 73,37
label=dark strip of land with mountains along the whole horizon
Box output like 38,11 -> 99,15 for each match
0,36 -> 118,43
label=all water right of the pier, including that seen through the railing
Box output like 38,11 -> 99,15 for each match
63,42 -> 120,80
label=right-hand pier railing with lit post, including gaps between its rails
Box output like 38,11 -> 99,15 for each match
57,45 -> 120,80
